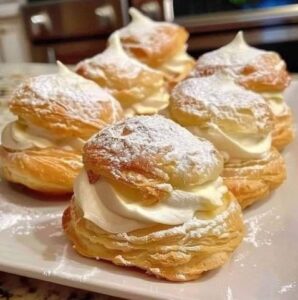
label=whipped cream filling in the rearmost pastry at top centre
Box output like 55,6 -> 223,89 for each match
158,46 -> 193,74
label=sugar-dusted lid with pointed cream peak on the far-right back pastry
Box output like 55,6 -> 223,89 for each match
191,31 -> 291,92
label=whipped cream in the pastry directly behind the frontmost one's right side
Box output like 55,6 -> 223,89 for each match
187,123 -> 271,160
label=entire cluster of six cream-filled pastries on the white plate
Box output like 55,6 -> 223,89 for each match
0,9 -> 293,281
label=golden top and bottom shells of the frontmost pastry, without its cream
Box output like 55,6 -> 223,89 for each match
62,116 -> 244,281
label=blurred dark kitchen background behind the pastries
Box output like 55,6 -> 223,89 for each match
0,0 -> 298,72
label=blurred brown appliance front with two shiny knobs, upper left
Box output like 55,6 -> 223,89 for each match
22,0 -> 128,64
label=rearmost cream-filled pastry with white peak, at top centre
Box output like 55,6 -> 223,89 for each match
119,8 -> 195,87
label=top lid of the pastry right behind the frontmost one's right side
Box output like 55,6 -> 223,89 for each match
170,72 -> 273,135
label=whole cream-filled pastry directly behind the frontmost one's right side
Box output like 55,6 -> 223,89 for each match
169,72 -> 286,208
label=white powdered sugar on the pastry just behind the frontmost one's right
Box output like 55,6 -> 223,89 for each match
172,72 -> 271,130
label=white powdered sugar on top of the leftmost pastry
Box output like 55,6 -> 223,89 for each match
15,65 -> 116,120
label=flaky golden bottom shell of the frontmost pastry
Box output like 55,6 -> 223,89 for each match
62,194 -> 244,281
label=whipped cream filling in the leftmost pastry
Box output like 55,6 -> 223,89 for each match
1,121 -> 85,151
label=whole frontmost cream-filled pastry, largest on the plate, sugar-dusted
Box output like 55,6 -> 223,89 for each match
62,115 -> 243,281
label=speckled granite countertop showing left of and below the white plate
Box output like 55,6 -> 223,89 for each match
0,64 -> 120,300
